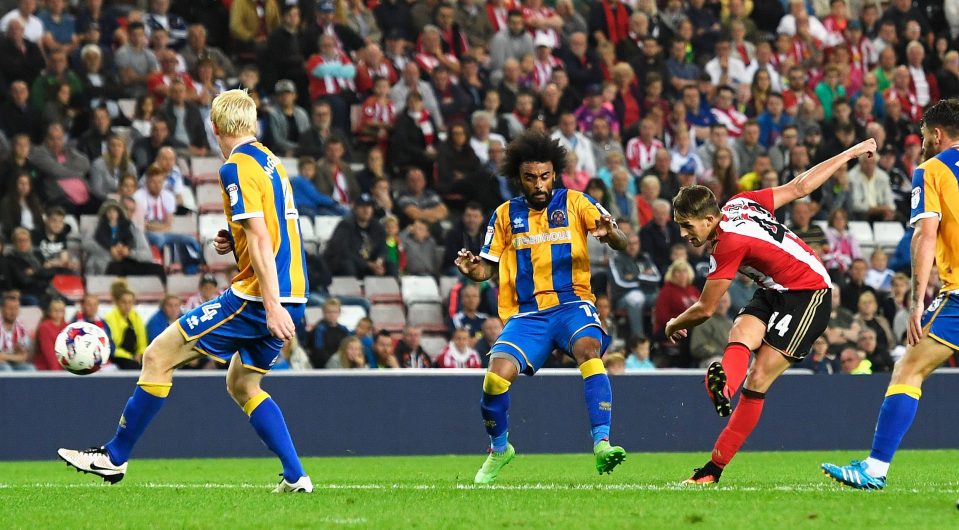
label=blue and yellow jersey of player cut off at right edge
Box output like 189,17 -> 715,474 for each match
909,147 -> 959,291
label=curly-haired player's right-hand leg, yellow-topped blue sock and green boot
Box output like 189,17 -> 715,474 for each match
572,332 -> 626,474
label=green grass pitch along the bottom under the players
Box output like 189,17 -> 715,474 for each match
0,451 -> 959,530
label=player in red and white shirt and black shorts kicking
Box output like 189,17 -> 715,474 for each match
668,138 -> 876,484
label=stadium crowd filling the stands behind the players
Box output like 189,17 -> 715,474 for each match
0,0 -> 959,374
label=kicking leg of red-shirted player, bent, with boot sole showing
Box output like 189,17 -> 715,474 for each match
706,314 -> 766,417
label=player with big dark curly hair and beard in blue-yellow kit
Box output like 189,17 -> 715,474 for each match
456,132 -> 626,484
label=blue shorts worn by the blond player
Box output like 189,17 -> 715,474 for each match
177,289 -> 306,374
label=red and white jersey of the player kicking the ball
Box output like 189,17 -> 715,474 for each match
707,188 -> 831,291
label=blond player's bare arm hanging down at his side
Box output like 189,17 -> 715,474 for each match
243,217 -> 296,340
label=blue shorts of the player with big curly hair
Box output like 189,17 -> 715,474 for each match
490,301 -> 609,375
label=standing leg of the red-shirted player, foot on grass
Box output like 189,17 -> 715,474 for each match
685,344 -> 790,484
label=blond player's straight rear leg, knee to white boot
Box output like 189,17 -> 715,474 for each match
226,354 -> 313,493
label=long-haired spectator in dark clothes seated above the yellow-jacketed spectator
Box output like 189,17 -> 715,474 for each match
82,200 -> 165,278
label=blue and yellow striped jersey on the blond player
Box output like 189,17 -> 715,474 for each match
220,141 -> 309,303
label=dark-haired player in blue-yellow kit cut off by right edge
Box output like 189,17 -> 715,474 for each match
822,99 -> 959,489
